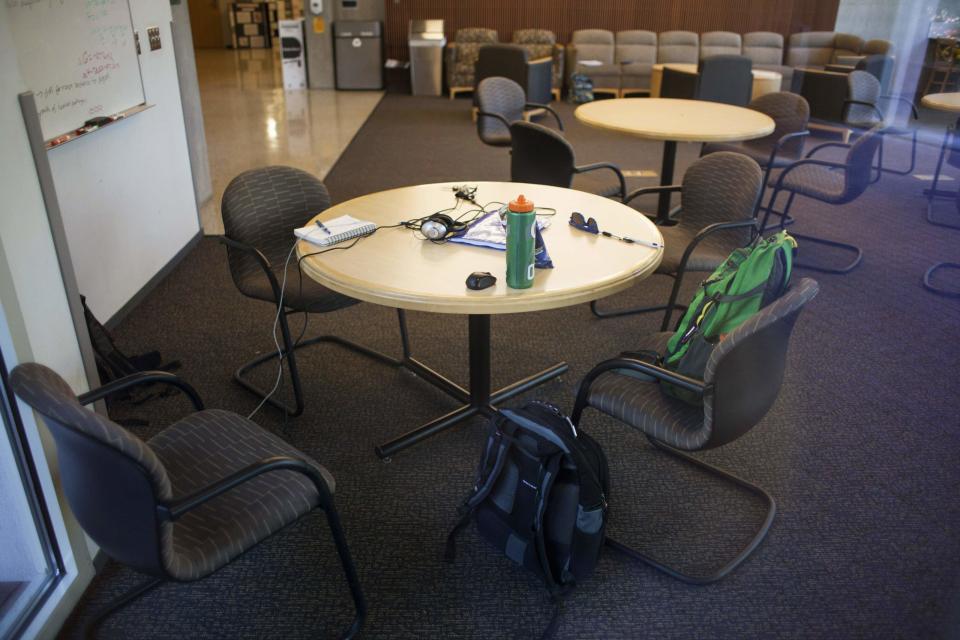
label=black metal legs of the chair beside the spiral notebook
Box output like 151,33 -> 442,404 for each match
240,310 -> 409,416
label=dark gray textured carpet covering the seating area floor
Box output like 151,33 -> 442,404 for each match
63,96 -> 960,639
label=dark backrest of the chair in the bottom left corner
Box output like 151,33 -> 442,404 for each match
10,363 -> 173,576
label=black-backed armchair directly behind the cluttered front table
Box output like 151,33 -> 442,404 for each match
510,121 -> 627,200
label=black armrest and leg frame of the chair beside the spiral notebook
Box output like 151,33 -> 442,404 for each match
220,236 -> 411,416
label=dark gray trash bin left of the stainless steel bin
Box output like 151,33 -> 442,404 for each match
333,20 -> 383,89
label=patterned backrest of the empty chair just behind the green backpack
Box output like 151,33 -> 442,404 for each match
679,151 -> 763,248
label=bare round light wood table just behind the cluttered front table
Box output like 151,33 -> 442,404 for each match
574,98 -> 775,224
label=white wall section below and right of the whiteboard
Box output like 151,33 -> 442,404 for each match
42,0 -> 200,320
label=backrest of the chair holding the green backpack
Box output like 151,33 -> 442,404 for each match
702,278 -> 820,449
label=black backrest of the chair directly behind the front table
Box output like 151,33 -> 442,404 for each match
510,120 -> 574,187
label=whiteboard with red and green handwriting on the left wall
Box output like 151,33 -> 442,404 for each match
4,0 -> 145,140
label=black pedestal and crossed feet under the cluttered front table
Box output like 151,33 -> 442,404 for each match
374,315 -> 569,458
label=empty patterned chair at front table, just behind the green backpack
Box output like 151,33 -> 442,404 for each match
590,151 -> 763,324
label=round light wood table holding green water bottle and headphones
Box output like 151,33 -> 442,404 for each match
297,182 -> 663,458
